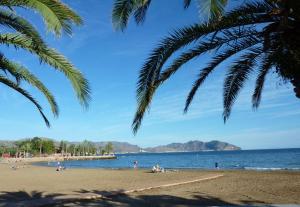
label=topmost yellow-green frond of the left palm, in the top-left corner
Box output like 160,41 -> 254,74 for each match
0,0 -> 82,36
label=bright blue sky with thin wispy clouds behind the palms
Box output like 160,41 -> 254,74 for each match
0,0 -> 300,149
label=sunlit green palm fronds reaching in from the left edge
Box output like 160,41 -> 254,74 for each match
0,0 -> 90,127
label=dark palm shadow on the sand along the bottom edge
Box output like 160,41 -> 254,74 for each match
0,189 -> 264,207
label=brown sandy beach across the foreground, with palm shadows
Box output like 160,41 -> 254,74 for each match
0,164 -> 300,206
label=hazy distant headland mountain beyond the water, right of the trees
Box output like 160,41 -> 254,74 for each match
143,140 -> 241,152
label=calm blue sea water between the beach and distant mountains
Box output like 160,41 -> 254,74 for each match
38,149 -> 300,170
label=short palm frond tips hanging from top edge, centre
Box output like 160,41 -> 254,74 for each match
112,0 -> 227,31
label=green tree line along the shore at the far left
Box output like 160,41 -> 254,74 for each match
0,137 -> 114,160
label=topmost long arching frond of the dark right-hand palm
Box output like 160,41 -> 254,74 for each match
137,4 -> 272,96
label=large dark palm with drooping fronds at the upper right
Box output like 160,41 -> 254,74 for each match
133,0 -> 300,133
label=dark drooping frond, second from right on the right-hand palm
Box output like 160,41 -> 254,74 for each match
223,48 -> 263,122
